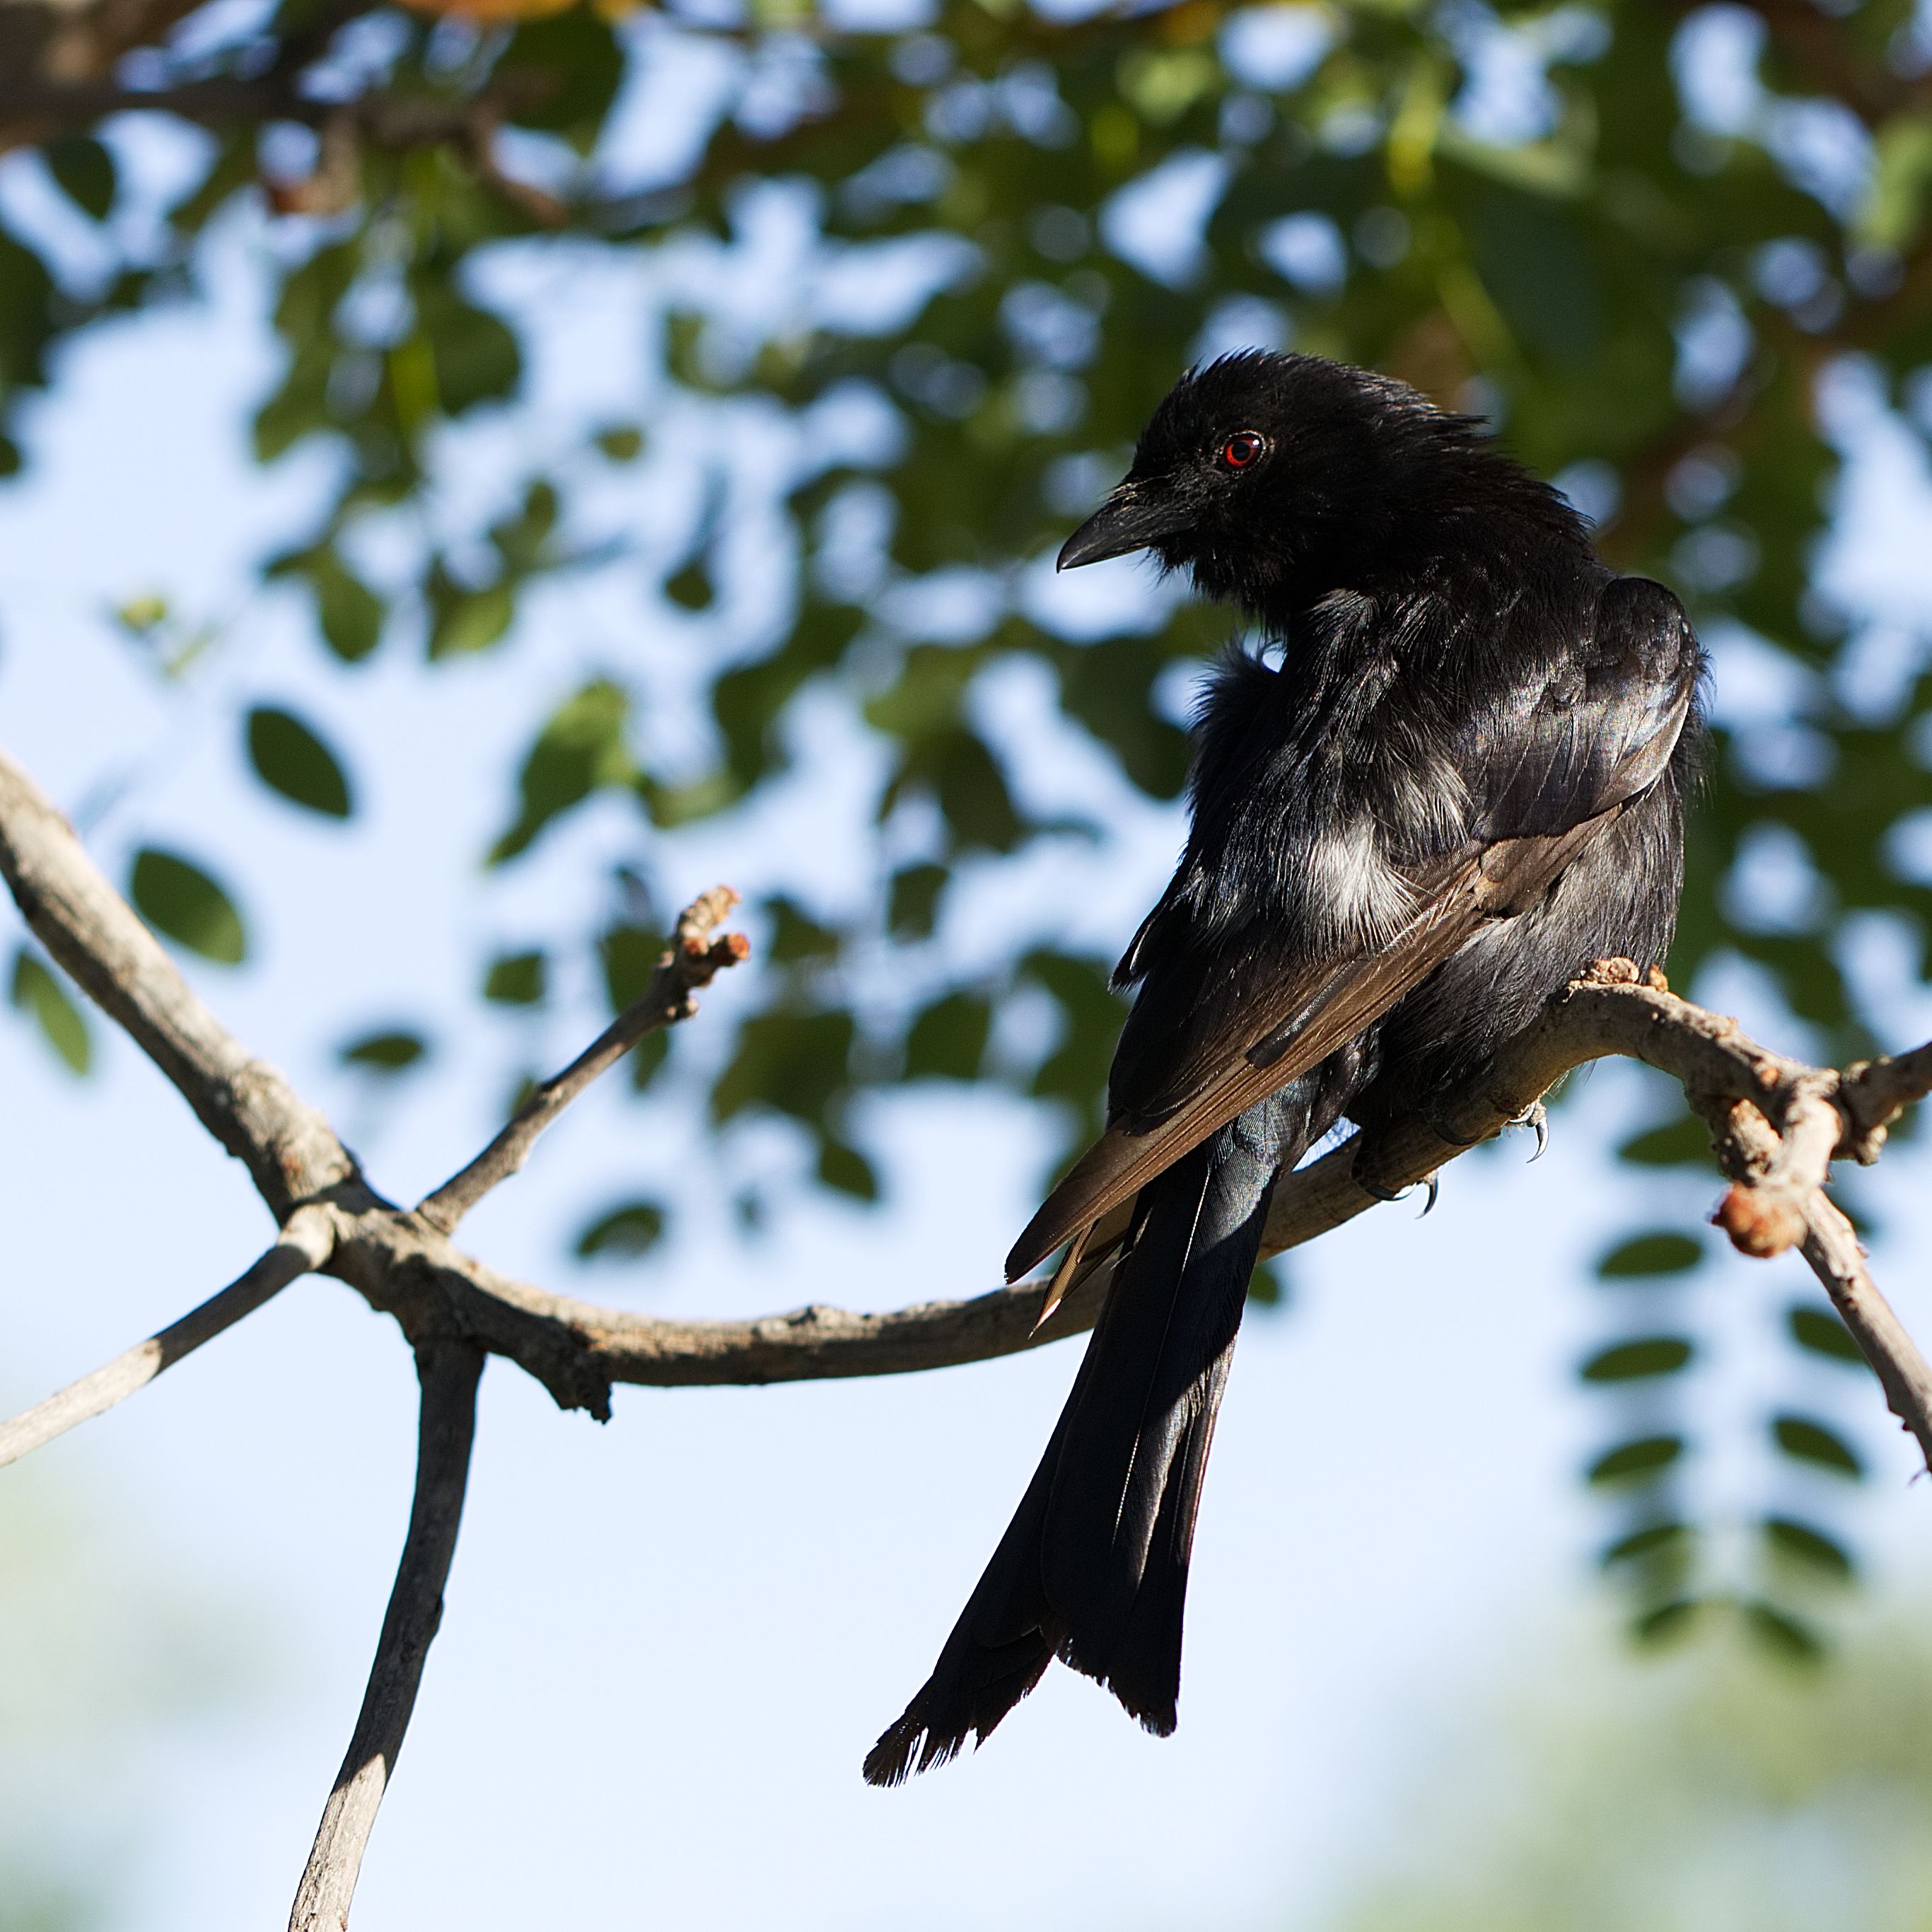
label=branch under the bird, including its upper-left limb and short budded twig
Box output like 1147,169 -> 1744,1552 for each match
0,722 -> 1932,1431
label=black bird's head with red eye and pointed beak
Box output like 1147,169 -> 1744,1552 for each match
1059,349 -> 1513,612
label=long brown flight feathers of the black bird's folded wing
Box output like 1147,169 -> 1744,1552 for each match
1006,804 -> 1623,1281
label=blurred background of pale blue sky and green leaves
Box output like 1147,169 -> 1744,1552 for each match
0,0 -> 1932,1932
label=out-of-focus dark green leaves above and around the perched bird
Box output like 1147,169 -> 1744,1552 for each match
0,0 -> 1932,1648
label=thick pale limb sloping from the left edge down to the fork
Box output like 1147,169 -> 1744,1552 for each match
0,752 -> 356,1221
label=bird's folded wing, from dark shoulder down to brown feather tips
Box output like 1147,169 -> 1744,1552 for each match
1006,578 -> 1702,1281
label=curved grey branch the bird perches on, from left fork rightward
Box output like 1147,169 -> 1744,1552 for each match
313,960 -> 1932,1416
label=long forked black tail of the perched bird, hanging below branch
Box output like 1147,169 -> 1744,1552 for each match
866,1084 -> 1327,1785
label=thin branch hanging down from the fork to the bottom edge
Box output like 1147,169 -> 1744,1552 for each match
288,1339 -> 483,1932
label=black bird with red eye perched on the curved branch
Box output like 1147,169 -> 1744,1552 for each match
866,351 -> 1704,1785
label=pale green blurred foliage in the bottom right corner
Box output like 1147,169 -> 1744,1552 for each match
1322,1610 -> 1932,1932
